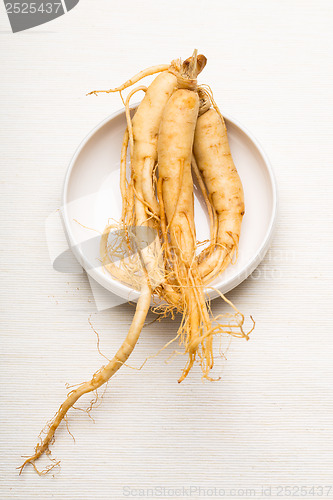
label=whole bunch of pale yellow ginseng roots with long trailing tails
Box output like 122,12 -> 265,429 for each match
20,50 -> 250,474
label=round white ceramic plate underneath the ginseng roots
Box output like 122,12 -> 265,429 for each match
62,110 -> 277,300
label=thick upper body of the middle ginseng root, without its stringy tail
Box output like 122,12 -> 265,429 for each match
158,89 -> 199,267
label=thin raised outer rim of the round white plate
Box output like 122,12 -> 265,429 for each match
61,103 -> 278,301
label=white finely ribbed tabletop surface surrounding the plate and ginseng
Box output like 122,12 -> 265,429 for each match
0,0 -> 333,500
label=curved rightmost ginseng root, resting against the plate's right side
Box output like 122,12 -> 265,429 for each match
193,108 -> 244,283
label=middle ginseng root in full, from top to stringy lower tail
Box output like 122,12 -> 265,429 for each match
158,81 -> 213,382
